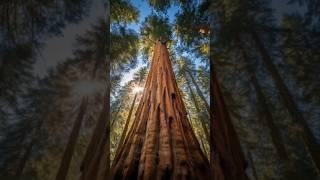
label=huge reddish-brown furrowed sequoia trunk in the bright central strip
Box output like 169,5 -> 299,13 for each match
111,41 -> 210,180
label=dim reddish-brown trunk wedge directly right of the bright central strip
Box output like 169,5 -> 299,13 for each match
210,66 -> 248,180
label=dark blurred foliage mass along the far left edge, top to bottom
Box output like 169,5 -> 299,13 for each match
0,0 -> 88,178
